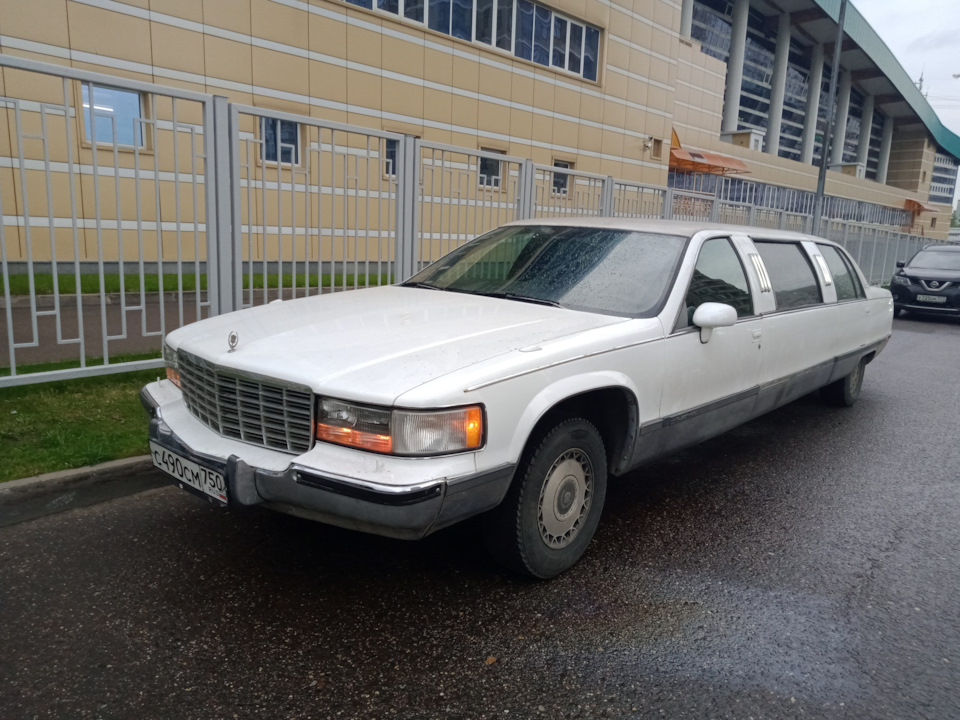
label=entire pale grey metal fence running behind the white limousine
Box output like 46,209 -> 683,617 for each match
0,55 -> 923,387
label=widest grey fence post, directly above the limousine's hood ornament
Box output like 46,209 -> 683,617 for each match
203,95 -> 240,315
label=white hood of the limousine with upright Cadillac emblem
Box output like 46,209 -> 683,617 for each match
167,286 -> 626,403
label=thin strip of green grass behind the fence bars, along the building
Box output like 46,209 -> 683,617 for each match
0,270 -> 392,295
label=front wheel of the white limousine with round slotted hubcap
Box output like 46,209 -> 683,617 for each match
484,418 -> 607,579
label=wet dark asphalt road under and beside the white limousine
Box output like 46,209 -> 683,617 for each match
0,319 -> 960,720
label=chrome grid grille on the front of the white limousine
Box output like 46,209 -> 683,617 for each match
177,352 -> 313,454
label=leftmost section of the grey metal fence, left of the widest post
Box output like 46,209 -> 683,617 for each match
0,56 -> 217,387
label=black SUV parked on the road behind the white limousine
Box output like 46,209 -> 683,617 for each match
890,245 -> 960,317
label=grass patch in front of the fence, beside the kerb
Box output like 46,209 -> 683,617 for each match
0,368 -> 163,482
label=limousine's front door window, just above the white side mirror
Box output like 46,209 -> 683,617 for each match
687,238 -> 753,320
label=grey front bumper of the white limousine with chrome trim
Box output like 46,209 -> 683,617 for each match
140,386 -> 515,539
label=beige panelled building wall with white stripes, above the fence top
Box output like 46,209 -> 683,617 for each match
0,0 -> 679,183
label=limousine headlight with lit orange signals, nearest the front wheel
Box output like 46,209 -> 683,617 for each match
316,398 -> 483,455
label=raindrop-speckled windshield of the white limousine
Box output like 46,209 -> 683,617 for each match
404,225 -> 687,317
